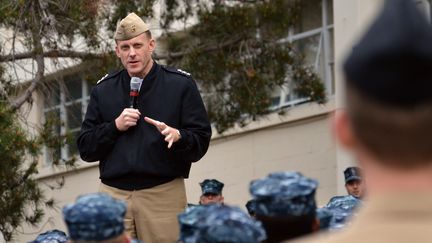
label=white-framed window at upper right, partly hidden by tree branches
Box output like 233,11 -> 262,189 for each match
270,0 -> 334,110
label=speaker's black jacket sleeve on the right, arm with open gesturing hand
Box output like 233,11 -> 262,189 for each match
173,79 -> 211,162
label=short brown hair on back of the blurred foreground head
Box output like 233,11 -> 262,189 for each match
346,80 -> 432,168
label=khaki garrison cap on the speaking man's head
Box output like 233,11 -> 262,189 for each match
114,13 -> 149,40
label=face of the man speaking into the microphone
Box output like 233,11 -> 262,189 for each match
116,33 -> 155,78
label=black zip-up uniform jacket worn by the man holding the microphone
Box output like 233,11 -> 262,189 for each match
77,62 -> 211,190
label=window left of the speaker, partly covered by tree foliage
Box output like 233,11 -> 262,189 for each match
44,76 -> 91,165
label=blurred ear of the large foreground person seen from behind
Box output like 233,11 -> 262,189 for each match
332,110 -> 355,150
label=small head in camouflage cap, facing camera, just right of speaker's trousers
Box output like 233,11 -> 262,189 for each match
200,179 -> 224,205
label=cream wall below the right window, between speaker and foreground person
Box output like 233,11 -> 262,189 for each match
187,105 -> 336,208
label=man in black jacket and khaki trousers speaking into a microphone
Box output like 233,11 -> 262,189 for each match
77,13 -> 211,243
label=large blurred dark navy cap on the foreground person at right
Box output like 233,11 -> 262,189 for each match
344,0 -> 432,107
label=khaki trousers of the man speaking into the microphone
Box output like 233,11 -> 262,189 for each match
99,178 -> 187,243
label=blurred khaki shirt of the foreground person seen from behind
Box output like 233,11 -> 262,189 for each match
290,191 -> 432,243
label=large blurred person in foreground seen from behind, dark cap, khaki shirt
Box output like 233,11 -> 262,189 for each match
292,0 -> 432,243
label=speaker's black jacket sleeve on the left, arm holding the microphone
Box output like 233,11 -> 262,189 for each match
77,87 -> 121,162
